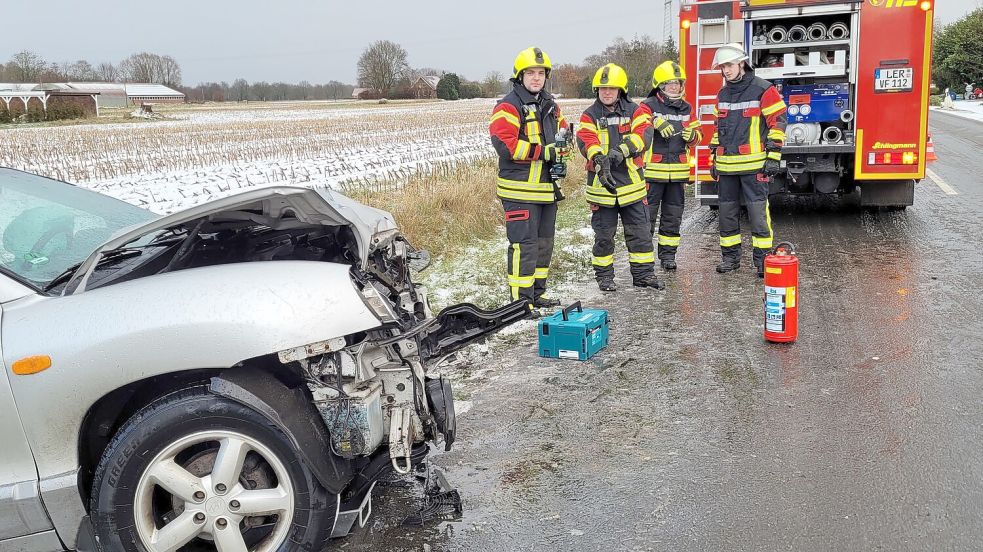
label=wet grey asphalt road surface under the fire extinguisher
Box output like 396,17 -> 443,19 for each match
338,112 -> 983,552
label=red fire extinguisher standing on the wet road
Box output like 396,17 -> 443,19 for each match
765,242 -> 799,343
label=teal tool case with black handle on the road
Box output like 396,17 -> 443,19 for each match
539,301 -> 608,360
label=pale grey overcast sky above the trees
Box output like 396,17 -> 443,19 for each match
0,0 -> 983,85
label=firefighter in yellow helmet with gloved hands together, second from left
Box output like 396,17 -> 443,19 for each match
577,63 -> 663,291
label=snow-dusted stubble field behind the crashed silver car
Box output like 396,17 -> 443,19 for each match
0,99 -> 586,213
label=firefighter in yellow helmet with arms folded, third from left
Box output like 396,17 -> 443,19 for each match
635,61 -> 703,270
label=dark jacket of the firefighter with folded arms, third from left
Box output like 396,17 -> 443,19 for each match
635,90 -> 703,182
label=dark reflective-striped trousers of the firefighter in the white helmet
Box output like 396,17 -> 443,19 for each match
717,173 -> 773,270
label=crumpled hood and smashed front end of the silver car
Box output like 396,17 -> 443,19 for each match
60,188 -> 529,492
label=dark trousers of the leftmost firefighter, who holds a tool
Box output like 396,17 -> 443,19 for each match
502,199 -> 556,303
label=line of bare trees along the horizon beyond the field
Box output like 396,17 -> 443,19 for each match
0,36 -> 678,102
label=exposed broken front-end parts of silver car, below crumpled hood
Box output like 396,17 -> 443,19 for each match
278,225 -> 529,473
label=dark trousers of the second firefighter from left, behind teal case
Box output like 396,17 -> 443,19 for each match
590,201 -> 655,281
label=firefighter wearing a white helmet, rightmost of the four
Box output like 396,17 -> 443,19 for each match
710,44 -> 786,277
